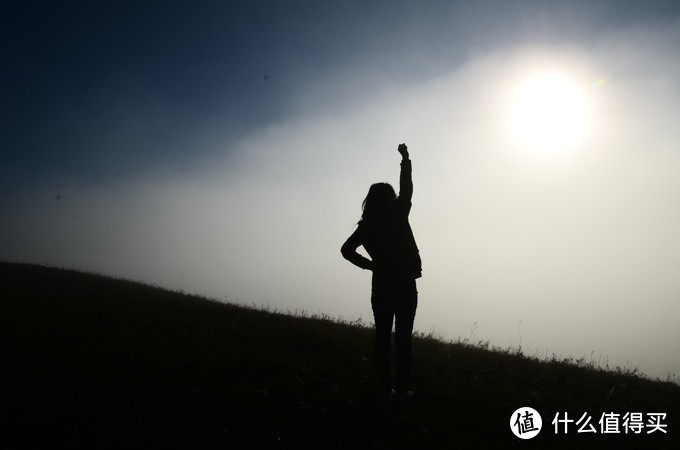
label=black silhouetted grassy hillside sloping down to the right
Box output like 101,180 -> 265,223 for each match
0,263 -> 680,449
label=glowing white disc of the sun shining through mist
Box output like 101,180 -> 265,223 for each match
508,72 -> 590,153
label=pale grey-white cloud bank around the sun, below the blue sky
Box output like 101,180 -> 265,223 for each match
0,15 -> 680,376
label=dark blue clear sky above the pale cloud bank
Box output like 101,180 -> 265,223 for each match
6,1 -> 680,181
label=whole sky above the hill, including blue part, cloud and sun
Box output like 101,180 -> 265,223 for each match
0,0 -> 680,379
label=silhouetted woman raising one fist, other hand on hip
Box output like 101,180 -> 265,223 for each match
341,144 -> 422,398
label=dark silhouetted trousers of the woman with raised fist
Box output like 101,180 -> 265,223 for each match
371,273 -> 418,394
